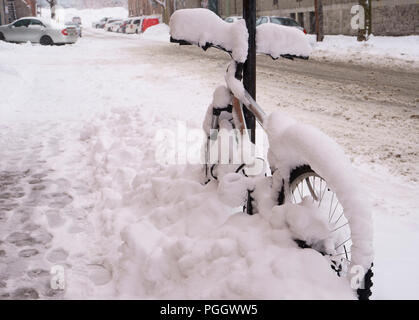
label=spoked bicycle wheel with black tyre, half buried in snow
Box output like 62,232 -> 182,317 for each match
289,165 -> 352,276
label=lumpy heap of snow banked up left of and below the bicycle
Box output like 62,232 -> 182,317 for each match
82,108 -> 354,299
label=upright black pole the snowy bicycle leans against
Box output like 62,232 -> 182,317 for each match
243,0 -> 256,143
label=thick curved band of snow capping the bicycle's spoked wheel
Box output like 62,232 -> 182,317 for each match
265,111 -> 374,272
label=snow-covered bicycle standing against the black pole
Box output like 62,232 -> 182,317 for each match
170,9 -> 373,300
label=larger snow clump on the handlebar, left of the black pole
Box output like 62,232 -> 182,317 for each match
170,8 -> 249,63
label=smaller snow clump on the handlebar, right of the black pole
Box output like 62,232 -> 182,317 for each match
256,23 -> 312,59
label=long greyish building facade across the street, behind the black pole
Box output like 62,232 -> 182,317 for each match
128,0 -> 419,36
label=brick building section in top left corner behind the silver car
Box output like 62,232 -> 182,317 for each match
0,0 -> 36,24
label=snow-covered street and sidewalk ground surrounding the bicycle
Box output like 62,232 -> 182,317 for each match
0,31 -> 419,299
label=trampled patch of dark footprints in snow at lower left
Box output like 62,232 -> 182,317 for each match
0,169 -> 74,299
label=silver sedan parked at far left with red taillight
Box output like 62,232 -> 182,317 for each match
0,17 -> 78,45
